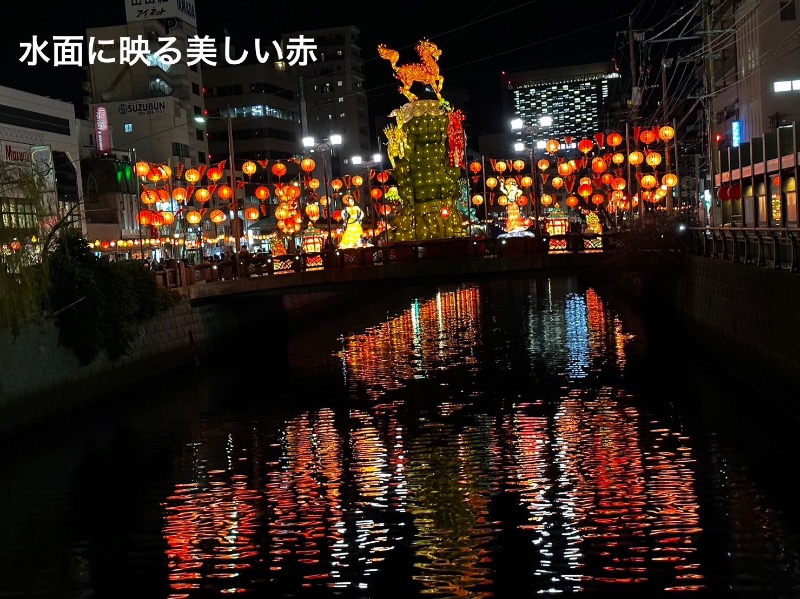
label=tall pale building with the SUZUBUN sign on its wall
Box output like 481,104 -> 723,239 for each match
85,0 -> 208,165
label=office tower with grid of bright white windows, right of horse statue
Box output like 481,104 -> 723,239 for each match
506,62 -> 621,141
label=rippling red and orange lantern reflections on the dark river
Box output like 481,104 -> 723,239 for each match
165,288 -> 703,597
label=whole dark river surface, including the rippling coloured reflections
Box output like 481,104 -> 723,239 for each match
0,278 -> 800,599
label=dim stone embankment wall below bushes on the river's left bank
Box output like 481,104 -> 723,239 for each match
0,292 -> 344,433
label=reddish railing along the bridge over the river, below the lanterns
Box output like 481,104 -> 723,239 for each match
177,232 -> 624,286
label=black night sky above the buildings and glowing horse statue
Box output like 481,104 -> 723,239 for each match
0,0 -> 664,133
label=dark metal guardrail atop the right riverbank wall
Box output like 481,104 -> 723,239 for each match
687,227 -> 800,272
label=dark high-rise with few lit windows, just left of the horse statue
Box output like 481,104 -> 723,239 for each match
283,26 -> 372,175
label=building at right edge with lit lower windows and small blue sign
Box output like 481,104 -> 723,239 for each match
704,0 -> 800,228
